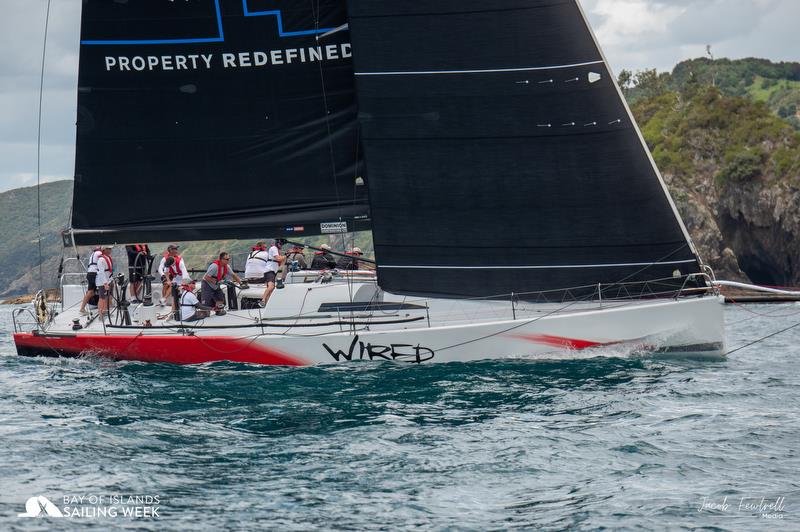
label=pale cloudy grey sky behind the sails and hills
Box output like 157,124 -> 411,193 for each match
0,0 -> 800,191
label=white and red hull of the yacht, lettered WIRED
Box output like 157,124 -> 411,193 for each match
15,283 -> 725,365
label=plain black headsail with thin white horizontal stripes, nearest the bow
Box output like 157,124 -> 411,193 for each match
348,0 -> 700,297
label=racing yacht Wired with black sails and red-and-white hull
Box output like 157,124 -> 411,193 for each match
14,0 -> 725,365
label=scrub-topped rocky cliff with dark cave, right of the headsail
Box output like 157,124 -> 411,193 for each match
633,84 -> 800,286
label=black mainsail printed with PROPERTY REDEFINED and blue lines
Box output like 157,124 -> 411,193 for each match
72,0 -> 369,244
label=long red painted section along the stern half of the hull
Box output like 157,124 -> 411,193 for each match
14,333 -> 307,366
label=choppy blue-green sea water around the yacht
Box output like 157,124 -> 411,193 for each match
0,304 -> 800,530
